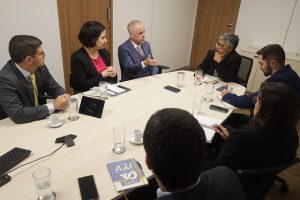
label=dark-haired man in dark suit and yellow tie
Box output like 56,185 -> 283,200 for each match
0,35 -> 69,124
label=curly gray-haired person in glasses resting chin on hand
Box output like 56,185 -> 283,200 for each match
198,33 -> 241,82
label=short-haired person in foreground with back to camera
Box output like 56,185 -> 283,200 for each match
143,108 -> 245,200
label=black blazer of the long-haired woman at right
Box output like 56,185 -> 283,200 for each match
210,125 -> 299,170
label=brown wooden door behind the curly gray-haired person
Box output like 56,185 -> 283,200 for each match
190,0 -> 241,69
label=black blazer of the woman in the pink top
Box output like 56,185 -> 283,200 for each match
70,47 -> 117,92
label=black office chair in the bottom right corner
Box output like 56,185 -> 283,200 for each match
237,158 -> 299,200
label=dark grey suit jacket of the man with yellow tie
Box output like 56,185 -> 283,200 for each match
0,61 -> 65,123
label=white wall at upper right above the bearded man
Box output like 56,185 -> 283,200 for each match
235,0 -> 300,53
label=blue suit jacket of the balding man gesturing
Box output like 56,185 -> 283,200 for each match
118,39 -> 157,81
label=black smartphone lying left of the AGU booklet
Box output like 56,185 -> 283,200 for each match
78,175 -> 99,200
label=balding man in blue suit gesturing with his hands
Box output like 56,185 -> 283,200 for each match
118,20 -> 158,81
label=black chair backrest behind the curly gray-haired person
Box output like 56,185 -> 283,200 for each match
238,56 -> 253,87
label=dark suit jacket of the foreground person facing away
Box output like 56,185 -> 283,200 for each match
157,167 -> 245,200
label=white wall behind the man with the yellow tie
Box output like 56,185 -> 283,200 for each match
0,0 -> 64,87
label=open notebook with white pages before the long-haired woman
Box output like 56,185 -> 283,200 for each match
194,114 -> 222,143
